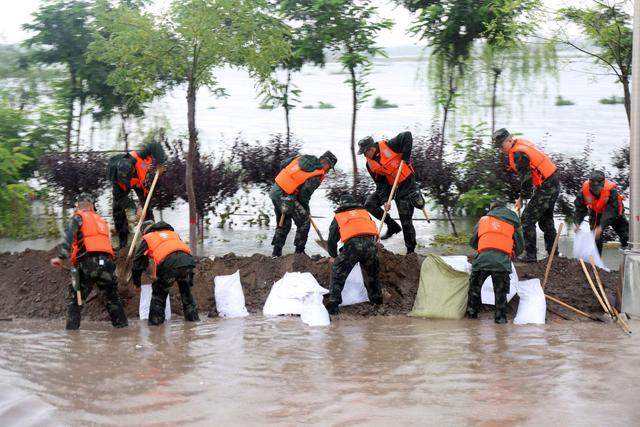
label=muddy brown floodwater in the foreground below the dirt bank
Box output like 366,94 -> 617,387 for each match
0,316 -> 640,426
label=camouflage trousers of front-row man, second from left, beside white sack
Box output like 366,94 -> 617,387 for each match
149,267 -> 200,325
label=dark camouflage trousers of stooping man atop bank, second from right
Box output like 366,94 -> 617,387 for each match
520,176 -> 560,256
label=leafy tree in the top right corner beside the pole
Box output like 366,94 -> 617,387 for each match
558,0 -> 633,125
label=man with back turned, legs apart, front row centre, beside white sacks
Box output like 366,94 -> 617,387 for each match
327,194 -> 382,314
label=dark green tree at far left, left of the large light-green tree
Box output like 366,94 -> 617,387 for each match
23,0 -> 91,153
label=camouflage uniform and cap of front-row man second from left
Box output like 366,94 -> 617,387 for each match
132,221 -> 200,325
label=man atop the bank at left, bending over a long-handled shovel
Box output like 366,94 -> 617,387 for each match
107,142 -> 167,249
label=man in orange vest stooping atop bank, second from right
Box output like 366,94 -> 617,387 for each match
493,128 -> 560,262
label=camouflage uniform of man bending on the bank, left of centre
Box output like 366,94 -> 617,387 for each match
269,155 -> 322,253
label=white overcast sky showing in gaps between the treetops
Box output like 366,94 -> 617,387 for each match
0,0 -> 584,47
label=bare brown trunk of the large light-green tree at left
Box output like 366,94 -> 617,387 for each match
185,76 -> 198,256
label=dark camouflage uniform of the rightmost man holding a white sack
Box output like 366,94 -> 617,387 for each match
573,178 -> 629,253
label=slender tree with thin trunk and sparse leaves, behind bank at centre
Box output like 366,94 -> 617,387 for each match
328,0 -> 393,194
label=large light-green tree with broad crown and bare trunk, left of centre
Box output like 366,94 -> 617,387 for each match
90,0 -> 290,253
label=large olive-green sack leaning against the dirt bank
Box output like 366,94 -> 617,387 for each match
408,255 -> 469,319
